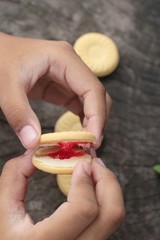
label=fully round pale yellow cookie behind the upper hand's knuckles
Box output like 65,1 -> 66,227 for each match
74,33 -> 119,77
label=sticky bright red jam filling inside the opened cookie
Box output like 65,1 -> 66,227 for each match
48,142 -> 89,160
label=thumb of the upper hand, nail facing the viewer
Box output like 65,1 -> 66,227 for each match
0,80 -> 41,149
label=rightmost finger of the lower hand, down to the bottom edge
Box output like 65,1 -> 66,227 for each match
77,159 -> 125,240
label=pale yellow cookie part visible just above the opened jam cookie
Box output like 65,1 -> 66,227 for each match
55,111 -> 82,132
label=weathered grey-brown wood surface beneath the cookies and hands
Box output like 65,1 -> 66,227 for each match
0,0 -> 160,240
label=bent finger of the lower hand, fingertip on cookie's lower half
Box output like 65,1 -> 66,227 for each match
31,163 -> 98,240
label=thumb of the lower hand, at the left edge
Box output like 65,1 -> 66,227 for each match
0,153 -> 35,219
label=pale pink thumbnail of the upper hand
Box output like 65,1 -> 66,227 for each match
18,125 -> 38,148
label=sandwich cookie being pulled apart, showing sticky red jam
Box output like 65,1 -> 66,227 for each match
32,131 -> 96,174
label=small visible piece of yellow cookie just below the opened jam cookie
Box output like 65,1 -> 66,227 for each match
57,174 -> 72,196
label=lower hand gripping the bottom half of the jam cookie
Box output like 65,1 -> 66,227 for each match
0,154 -> 125,240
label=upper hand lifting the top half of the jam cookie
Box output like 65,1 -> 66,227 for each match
0,33 -> 111,148
